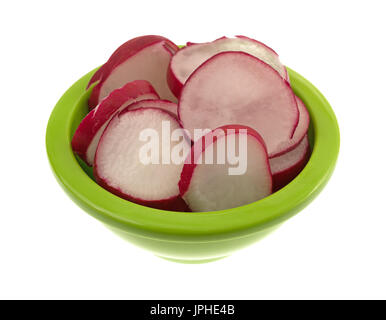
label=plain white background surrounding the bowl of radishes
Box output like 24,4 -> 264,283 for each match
0,0 -> 386,299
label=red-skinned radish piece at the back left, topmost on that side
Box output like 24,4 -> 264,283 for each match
88,36 -> 178,109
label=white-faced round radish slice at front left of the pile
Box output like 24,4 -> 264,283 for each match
94,108 -> 190,210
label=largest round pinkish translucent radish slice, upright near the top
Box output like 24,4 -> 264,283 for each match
178,51 -> 299,156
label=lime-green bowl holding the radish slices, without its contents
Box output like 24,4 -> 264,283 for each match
46,69 -> 339,263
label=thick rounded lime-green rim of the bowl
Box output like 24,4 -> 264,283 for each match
46,67 -> 340,240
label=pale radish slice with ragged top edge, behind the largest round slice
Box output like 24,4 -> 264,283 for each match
168,36 -> 288,97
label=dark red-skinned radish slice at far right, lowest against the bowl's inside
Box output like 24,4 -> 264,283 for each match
269,135 -> 310,191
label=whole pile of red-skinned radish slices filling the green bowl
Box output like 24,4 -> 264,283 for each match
72,36 -> 310,212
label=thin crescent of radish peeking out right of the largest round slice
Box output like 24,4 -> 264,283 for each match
270,97 -> 310,158
